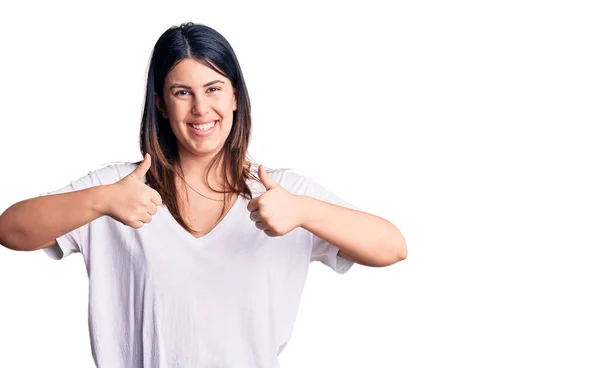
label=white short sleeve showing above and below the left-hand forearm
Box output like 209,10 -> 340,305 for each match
40,165 -> 131,260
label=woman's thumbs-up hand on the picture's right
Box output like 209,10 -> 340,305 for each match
248,165 -> 301,237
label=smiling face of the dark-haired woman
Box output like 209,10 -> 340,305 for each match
155,59 -> 237,156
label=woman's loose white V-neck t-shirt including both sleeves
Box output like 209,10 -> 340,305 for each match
42,163 -> 356,368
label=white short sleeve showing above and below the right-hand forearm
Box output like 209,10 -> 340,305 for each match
280,168 -> 359,275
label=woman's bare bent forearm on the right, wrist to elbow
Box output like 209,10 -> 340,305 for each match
298,196 -> 407,267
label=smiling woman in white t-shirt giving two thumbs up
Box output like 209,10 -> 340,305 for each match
0,23 -> 406,367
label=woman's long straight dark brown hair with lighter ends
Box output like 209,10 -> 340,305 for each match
137,23 -> 259,232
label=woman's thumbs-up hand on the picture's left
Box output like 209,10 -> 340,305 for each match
106,154 -> 162,229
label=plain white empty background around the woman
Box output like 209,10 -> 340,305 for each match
0,1 -> 600,368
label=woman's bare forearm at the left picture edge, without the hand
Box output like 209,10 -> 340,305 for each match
0,186 -> 106,251
